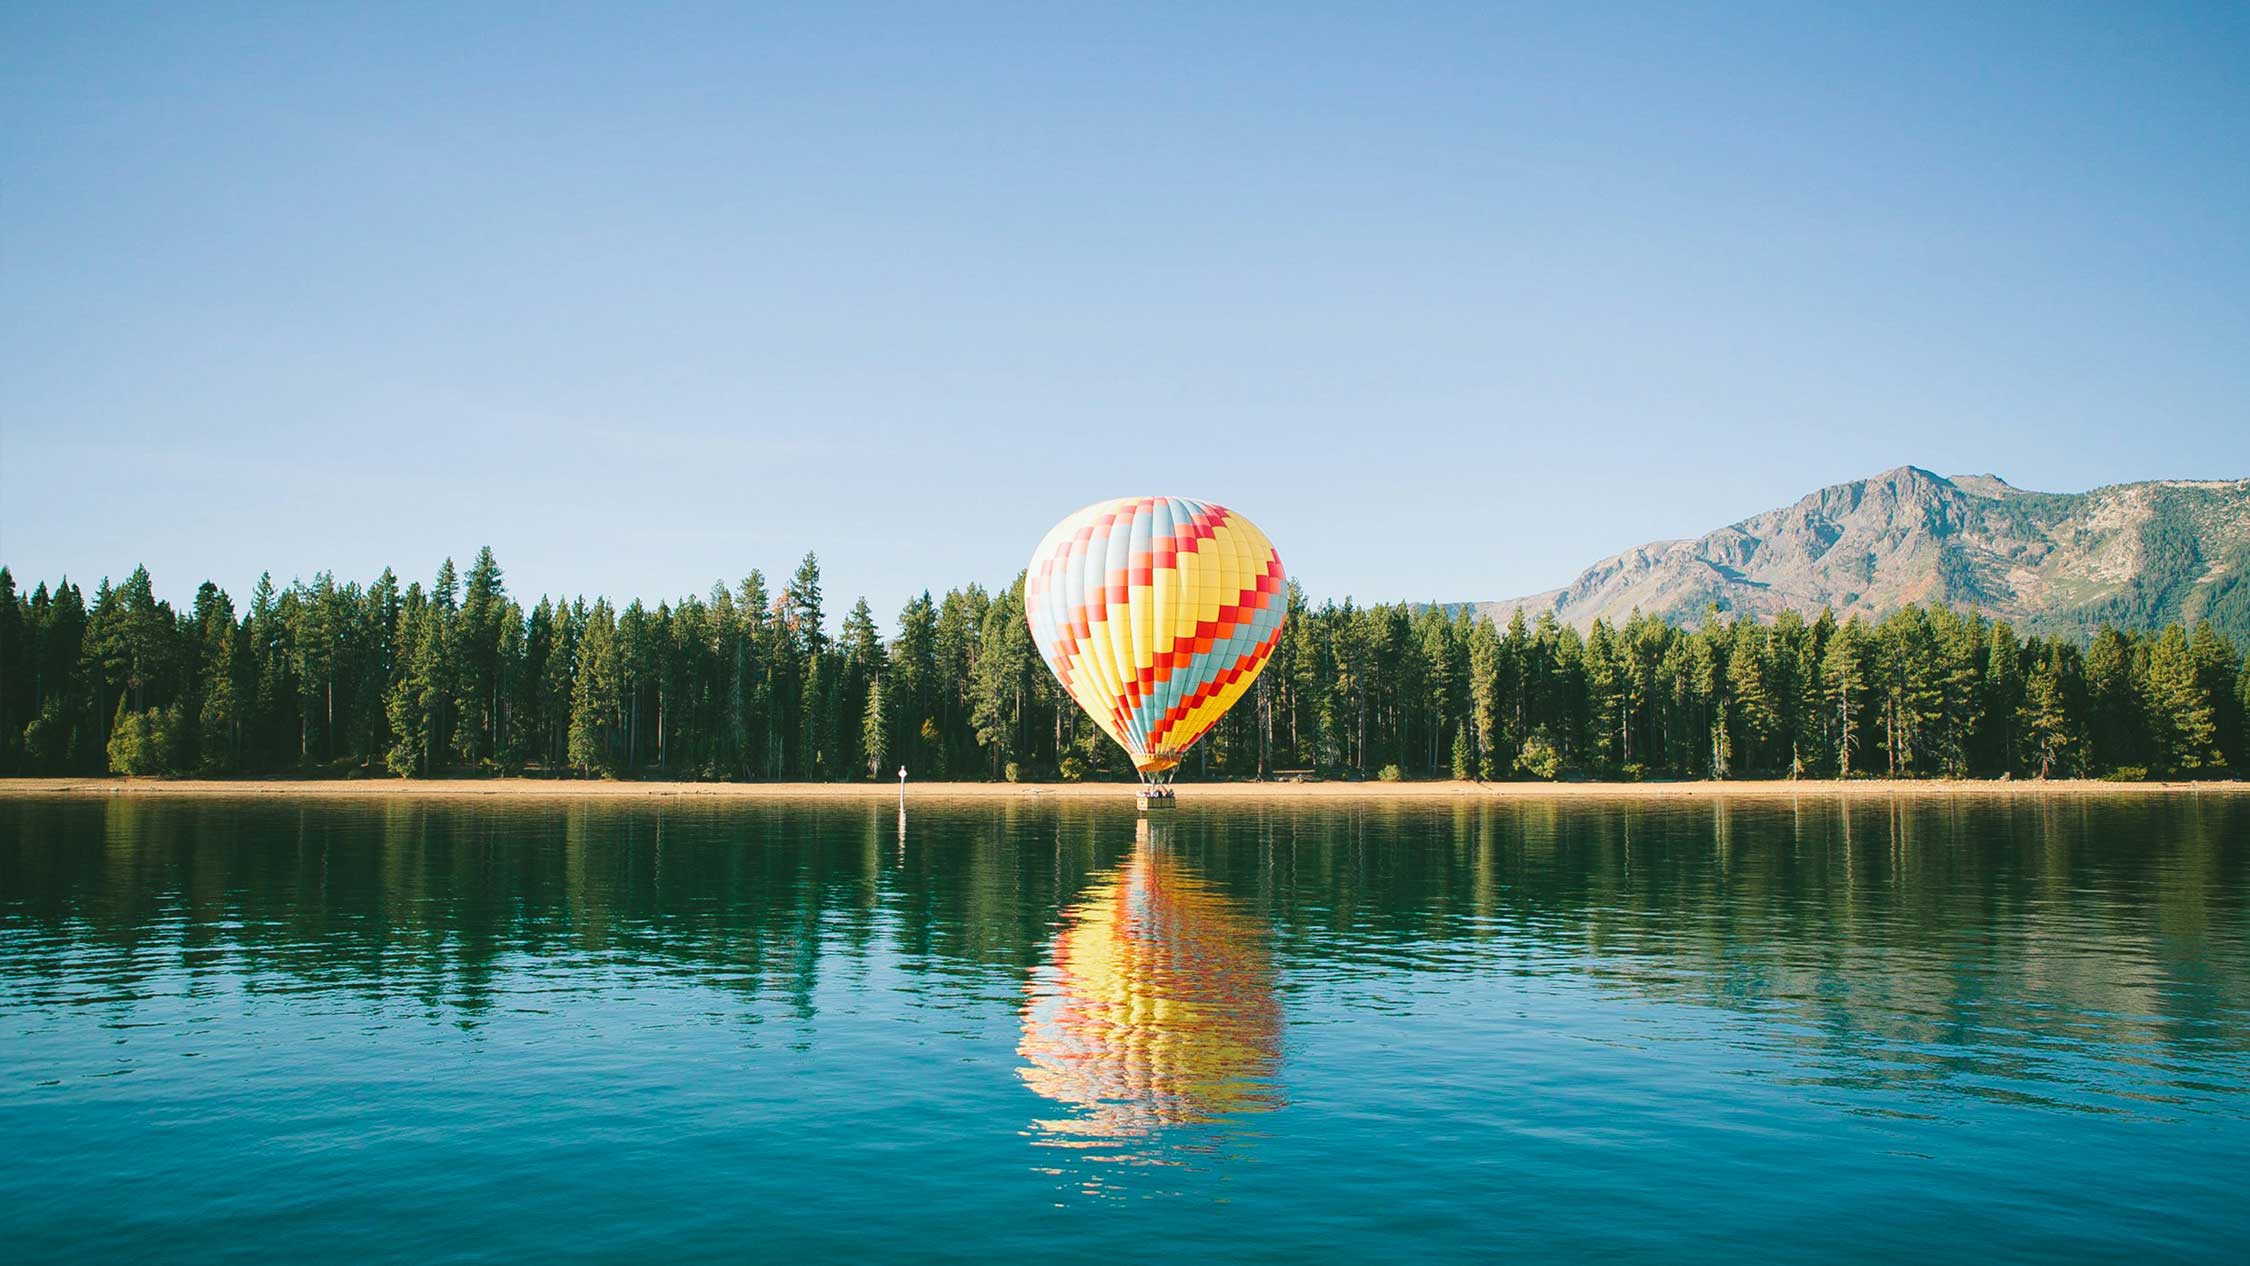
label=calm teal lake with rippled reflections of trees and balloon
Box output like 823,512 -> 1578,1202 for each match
0,787 -> 2250,1266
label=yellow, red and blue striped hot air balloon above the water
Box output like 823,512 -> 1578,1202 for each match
1024,497 -> 1287,805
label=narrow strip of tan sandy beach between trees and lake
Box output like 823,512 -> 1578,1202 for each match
0,778 -> 2250,803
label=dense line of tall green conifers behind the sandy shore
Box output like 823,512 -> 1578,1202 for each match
0,549 -> 2250,780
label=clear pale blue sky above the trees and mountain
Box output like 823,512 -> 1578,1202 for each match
0,2 -> 2250,623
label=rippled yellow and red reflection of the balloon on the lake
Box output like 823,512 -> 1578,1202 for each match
1017,821 -> 1280,1147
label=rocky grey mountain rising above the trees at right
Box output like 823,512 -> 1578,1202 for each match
1476,465 -> 2250,643
